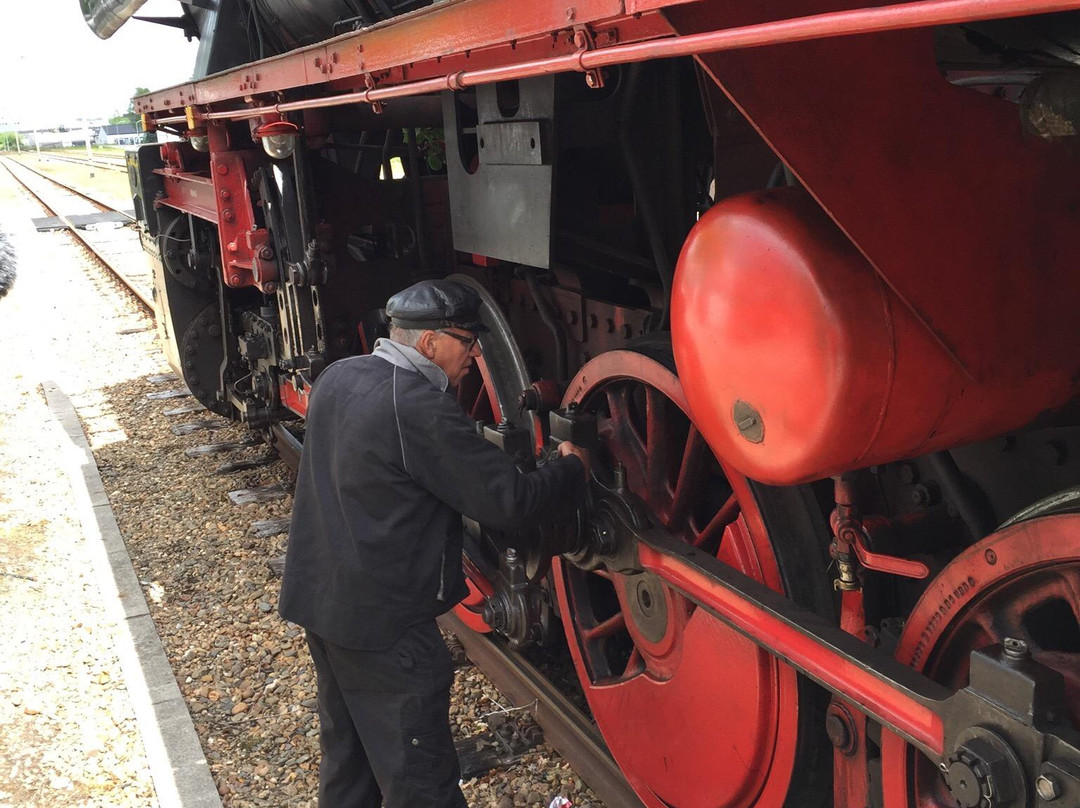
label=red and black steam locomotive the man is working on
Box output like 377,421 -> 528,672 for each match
82,0 -> 1080,808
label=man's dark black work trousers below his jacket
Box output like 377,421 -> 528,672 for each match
308,622 -> 468,808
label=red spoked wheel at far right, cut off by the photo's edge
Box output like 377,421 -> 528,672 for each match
881,514 -> 1080,808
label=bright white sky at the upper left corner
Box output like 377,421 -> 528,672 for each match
0,0 -> 198,127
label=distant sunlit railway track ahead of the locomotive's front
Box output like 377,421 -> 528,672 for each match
0,158 -> 154,314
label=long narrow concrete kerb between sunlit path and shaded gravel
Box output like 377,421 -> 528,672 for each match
41,381 -> 221,808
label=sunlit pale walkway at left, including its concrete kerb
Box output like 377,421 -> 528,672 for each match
0,165 -> 221,808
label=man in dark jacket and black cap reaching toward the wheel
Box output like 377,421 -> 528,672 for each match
280,281 -> 588,808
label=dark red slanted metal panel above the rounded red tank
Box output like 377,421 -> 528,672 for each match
667,0 -> 1080,388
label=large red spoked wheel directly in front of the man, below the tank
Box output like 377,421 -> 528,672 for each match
555,351 -> 812,808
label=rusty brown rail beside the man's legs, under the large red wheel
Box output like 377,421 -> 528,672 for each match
438,611 -> 644,808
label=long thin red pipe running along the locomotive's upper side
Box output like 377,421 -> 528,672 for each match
190,0 -> 1080,124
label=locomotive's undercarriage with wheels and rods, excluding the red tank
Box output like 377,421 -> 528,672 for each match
124,4 -> 1080,808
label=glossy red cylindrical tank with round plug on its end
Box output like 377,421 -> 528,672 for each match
672,189 -> 1078,485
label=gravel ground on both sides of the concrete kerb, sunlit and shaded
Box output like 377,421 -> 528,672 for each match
0,160 -> 600,808
